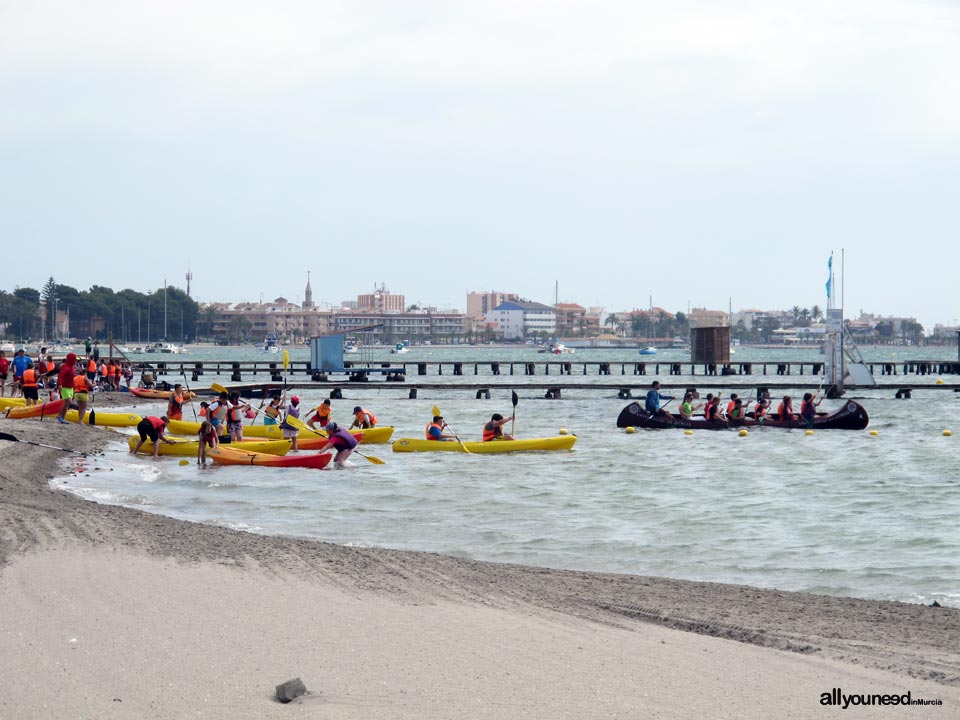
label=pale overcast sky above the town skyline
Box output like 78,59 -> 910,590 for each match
0,0 -> 960,331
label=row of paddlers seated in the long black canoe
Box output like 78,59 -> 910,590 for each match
644,380 -> 823,428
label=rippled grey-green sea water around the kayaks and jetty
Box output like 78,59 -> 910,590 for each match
53,347 -> 960,606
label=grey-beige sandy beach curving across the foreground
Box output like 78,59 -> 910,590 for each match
0,395 -> 960,720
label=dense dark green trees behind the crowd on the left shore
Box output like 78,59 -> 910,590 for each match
0,277 -> 200,344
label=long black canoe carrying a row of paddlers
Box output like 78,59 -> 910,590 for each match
617,400 -> 870,430
